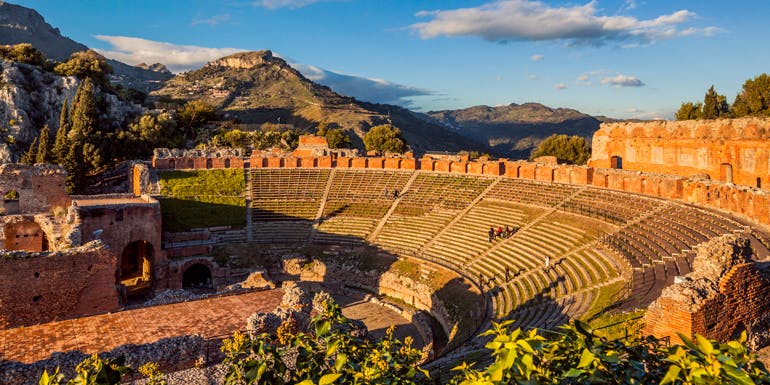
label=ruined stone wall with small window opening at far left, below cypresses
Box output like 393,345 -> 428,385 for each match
0,163 -> 70,214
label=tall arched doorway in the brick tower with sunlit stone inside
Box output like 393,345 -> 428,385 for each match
120,240 -> 154,297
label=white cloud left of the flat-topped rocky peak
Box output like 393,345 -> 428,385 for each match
94,35 -> 245,73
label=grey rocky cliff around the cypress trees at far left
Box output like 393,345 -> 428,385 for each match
0,60 -> 142,163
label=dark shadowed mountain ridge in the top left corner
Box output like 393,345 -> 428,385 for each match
0,1 -> 172,91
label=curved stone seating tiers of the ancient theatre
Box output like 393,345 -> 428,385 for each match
244,169 -> 770,328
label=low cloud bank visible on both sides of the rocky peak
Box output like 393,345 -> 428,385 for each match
96,35 -> 433,106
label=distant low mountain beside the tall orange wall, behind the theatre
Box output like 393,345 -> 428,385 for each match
427,103 -> 611,158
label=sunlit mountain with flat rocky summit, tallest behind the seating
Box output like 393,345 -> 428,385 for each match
151,50 -> 488,152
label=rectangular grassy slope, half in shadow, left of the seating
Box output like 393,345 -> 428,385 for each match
158,169 -> 246,232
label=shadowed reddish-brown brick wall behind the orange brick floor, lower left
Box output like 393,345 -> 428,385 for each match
0,242 -> 121,329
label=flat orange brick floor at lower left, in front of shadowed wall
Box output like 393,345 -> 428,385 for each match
0,290 -> 283,363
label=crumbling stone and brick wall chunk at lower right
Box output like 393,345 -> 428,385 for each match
645,235 -> 770,343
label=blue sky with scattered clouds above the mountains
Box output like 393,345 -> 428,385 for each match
11,0 -> 770,118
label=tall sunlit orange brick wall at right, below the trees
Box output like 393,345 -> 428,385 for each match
589,118 -> 770,188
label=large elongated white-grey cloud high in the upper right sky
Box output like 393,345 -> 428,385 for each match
409,0 -> 719,45
